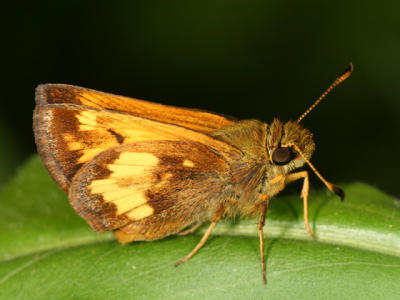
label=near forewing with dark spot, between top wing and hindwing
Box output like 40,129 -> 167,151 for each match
34,104 -> 240,191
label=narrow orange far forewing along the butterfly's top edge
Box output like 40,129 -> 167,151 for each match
36,84 -> 234,132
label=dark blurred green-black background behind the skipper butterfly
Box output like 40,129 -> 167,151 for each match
0,0 -> 400,196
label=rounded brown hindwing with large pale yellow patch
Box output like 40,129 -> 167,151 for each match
69,141 -> 231,234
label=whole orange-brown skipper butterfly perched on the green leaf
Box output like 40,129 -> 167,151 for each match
34,64 -> 352,282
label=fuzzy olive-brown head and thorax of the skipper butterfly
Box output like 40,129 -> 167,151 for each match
211,119 -> 314,215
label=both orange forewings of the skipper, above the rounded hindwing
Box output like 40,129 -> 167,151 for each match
34,84 -> 238,192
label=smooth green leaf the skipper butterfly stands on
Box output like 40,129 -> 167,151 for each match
0,156 -> 400,299
